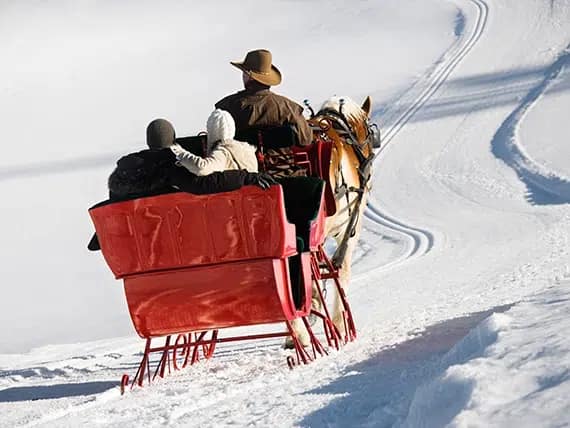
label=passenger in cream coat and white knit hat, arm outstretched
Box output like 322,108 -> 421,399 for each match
170,109 -> 258,175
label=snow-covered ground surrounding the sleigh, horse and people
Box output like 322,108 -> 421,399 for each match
0,0 -> 570,427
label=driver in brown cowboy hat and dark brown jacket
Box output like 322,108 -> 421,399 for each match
216,49 -> 313,146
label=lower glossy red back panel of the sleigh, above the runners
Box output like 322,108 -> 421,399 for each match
124,253 -> 311,337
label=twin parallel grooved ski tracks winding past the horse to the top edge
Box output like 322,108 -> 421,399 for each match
364,0 -> 489,270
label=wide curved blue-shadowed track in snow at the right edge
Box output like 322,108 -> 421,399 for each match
491,45 -> 570,205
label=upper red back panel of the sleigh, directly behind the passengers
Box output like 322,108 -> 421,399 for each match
89,186 -> 296,278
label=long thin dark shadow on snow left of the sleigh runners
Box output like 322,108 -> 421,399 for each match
0,381 -> 118,403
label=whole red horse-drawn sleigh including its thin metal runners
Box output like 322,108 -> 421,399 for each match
89,135 -> 356,391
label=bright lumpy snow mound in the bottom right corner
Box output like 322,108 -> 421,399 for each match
402,284 -> 570,427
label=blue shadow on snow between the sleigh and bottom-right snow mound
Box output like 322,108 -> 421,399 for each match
298,305 -> 512,428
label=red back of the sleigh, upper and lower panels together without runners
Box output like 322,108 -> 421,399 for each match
89,186 -> 311,338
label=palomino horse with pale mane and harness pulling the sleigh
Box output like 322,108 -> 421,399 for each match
309,97 -> 380,331
